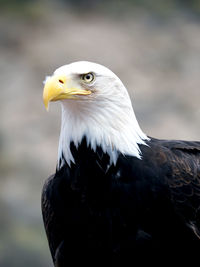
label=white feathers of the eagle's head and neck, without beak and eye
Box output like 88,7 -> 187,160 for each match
50,61 -> 148,169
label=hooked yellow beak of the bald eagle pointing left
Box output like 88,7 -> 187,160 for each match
43,75 -> 91,110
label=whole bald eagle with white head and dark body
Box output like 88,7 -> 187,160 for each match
42,61 -> 200,267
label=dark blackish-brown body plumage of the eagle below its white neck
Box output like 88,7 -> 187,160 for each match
42,139 -> 200,267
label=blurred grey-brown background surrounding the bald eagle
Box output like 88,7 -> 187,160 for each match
0,0 -> 200,267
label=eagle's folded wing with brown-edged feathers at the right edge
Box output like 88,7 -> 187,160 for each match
159,141 -> 200,238
